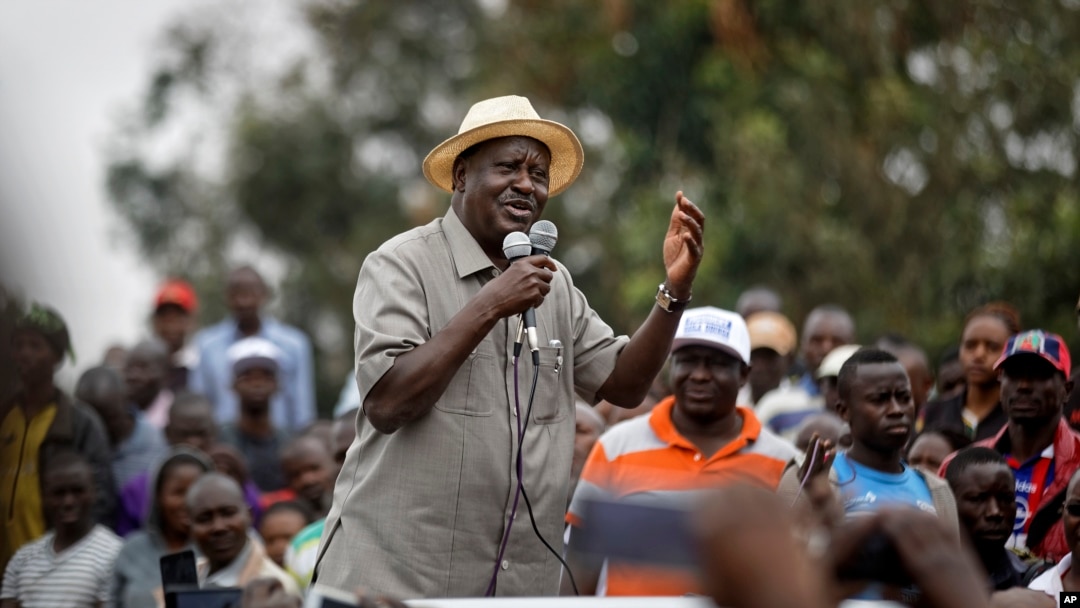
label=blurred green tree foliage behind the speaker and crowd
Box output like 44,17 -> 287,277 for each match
109,0 -> 1080,409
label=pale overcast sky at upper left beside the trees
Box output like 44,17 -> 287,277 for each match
0,0 -> 205,383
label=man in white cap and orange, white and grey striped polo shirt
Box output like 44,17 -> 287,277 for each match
564,307 -> 796,596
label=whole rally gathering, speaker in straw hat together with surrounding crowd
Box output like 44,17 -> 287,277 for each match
6,97 -> 1080,608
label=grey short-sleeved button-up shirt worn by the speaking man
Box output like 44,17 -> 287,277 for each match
316,210 -> 627,598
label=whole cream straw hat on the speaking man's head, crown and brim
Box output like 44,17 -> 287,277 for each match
423,95 -> 585,197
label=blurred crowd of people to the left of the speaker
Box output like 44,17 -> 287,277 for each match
0,273 -> 359,608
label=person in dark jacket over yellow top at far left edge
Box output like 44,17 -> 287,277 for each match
0,305 -> 114,568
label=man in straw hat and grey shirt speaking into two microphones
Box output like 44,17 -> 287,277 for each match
314,96 -> 705,598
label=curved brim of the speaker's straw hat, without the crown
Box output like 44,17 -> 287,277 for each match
423,119 -> 585,197
